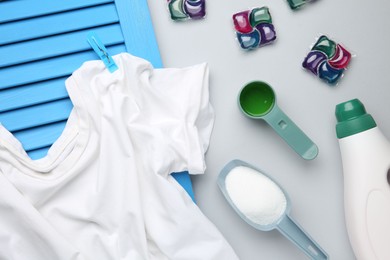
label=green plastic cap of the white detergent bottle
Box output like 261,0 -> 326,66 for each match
336,99 -> 376,139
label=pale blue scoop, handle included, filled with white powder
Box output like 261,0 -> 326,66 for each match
218,160 -> 328,260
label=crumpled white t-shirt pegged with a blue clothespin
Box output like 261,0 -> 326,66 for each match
0,53 -> 238,260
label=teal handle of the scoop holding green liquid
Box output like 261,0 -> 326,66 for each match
262,104 -> 318,160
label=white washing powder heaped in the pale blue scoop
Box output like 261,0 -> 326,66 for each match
225,166 -> 287,225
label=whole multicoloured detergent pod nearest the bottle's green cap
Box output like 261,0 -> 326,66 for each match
302,35 -> 352,85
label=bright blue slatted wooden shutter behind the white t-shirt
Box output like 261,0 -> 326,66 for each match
0,0 -> 193,199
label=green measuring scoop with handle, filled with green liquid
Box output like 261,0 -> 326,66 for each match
238,81 -> 318,160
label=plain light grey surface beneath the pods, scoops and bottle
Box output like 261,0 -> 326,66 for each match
148,0 -> 390,260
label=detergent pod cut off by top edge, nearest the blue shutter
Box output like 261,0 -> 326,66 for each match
168,0 -> 206,21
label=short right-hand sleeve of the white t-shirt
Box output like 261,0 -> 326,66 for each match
133,63 -> 214,175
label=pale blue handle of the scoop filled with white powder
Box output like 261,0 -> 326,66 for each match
276,215 -> 328,260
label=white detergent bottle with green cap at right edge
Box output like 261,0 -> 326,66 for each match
336,99 -> 390,260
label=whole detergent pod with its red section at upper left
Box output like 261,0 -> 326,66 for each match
232,7 -> 276,50
